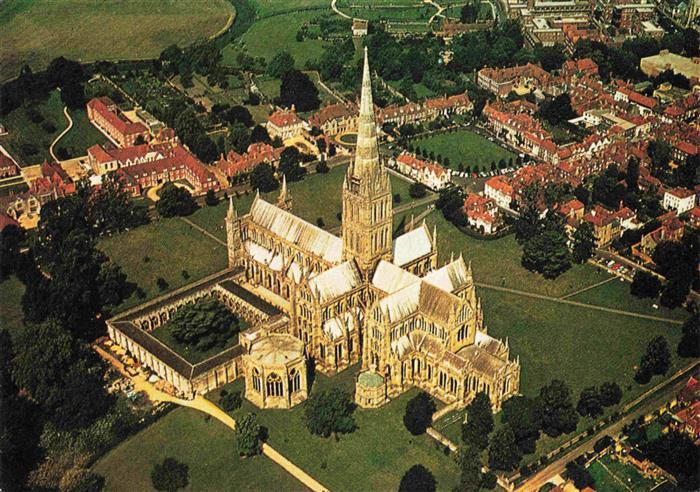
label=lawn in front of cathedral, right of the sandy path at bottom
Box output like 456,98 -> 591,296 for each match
209,366 -> 459,491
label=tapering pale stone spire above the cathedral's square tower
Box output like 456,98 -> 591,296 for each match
350,47 -> 381,178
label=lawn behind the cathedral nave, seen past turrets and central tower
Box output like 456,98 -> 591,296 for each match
190,165 -> 411,240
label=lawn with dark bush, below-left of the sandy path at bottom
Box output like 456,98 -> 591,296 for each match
93,408 -> 305,492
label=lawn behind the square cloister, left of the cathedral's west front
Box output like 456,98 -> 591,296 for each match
98,218 -> 227,310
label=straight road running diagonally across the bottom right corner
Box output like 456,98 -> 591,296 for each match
516,362 -> 700,492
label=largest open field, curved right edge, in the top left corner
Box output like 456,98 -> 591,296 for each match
0,0 -> 234,80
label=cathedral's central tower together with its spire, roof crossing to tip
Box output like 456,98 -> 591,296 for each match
342,48 -> 393,276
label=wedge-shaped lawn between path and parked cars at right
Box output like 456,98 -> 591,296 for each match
567,279 -> 690,321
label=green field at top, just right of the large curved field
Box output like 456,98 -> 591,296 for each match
222,11 -> 330,69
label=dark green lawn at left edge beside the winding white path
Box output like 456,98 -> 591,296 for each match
0,92 -> 68,167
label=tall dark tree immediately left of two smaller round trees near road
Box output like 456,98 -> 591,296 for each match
536,379 -> 578,437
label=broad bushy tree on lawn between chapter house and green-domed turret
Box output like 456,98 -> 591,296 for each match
304,388 -> 356,439
